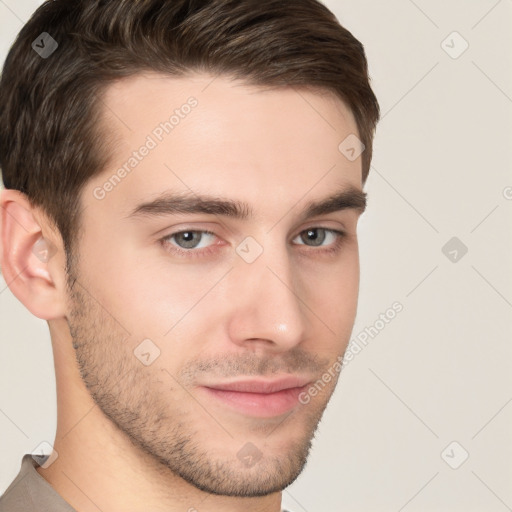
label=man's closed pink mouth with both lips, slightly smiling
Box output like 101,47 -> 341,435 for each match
200,376 -> 310,418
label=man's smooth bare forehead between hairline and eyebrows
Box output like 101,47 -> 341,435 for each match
86,73 -> 361,222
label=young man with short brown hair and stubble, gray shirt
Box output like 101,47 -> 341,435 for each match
0,0 -> 379,512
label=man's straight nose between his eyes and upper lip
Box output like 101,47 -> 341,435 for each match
228,243 -> 308,353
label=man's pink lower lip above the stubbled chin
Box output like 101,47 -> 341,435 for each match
201,385 -> 307,418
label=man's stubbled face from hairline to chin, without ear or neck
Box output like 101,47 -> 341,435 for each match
67,74 -> 361,496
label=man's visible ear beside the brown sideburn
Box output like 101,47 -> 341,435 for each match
0,189 -> 66,320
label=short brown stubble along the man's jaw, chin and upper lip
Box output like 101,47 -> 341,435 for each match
68,258 -> 344,497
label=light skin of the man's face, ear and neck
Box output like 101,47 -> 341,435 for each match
0,73 -> 362,512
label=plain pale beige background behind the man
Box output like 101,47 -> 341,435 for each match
0,0 -> 512,512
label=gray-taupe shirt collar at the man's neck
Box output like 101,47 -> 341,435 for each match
0,453 -> 294,512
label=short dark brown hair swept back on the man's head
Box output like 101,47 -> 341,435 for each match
0,0 -> 379,266
